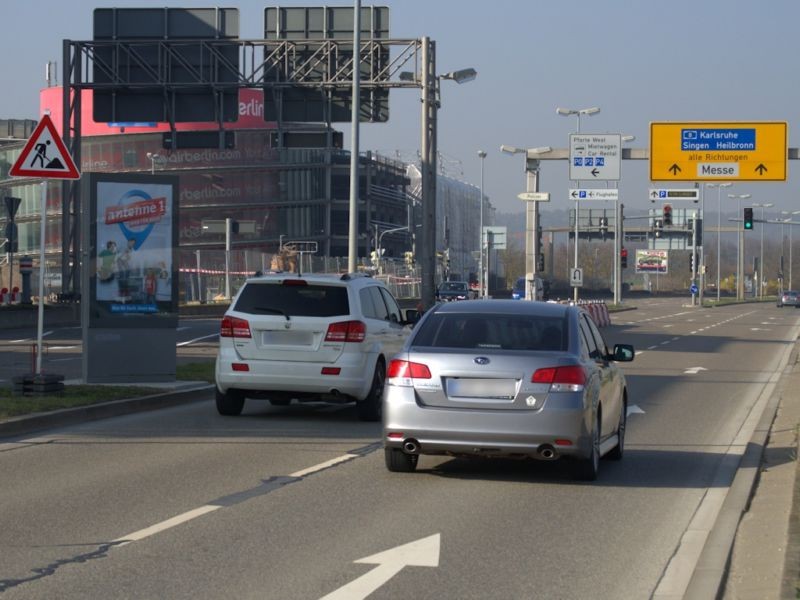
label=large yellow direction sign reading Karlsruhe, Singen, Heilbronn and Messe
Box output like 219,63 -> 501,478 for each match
650,121 -> 788,181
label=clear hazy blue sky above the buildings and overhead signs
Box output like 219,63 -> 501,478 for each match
0,0 -> 800,218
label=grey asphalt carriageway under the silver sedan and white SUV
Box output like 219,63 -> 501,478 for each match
0,299 -> 800,600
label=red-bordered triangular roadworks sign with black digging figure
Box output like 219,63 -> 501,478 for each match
8,115 -> 81,179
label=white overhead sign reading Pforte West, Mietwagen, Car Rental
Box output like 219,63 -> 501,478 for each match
569,133 -> 622,181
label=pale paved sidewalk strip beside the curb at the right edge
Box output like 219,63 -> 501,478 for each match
720,345 -> 800,600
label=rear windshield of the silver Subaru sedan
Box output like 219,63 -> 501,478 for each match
411,313 -> 567,352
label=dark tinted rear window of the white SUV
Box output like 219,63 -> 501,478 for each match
234,283 -> 350,317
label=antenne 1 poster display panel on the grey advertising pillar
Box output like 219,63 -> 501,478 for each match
88,174 -> 179,327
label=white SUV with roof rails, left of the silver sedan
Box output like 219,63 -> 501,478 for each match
215,273 -> 410,421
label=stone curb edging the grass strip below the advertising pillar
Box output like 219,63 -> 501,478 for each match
0,384 -> 214,438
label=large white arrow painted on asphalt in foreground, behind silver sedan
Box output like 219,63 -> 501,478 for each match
320,533 -> 441,600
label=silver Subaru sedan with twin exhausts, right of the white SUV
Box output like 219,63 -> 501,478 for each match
383,300 -> 634,480
